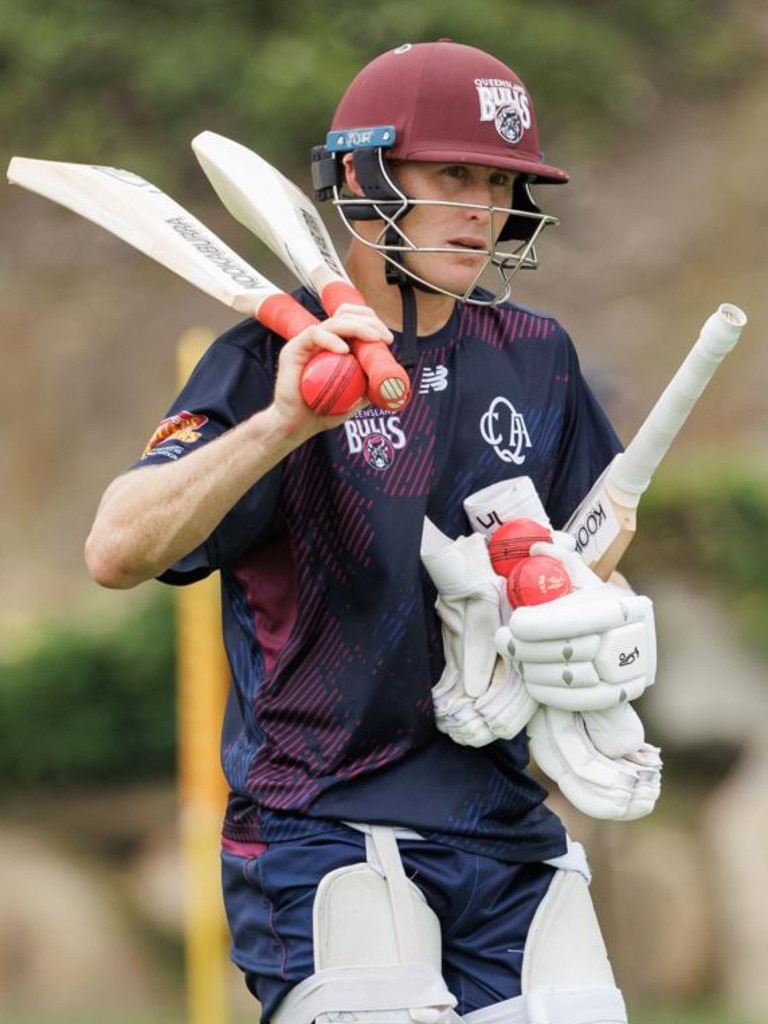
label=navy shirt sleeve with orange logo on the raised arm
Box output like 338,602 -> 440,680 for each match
131,322 -> 282,585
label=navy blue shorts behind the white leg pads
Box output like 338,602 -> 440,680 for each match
222,826 -> 555,1021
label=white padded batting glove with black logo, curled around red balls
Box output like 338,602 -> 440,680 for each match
496,543 -> 656,712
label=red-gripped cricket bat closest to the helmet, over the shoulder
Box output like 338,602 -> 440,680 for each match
191,131 -> 411,412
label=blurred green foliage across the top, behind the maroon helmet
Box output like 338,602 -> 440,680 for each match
0,0 -> 761,188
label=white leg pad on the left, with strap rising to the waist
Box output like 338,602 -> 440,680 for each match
271,827 -> 460,1024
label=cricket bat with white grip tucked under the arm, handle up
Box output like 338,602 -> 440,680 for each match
565,303 -> 746,580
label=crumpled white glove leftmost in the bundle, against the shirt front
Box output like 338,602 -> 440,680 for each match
422,519 -> 537,746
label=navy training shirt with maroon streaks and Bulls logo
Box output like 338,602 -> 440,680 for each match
137,292 -> 621,861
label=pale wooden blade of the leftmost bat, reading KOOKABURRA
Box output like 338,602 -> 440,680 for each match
7,157 -> 282,316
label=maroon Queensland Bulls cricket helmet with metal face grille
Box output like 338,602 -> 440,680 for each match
312,40 -> 568,305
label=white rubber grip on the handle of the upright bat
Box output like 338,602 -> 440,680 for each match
609,303 -> 746,496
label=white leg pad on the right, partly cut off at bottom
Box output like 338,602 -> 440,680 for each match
464,870 -> 627,1024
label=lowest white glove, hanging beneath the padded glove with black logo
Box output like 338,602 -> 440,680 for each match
527,706 -> 662,821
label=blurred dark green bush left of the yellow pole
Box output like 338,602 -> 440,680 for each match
0,589 -> 176,790
